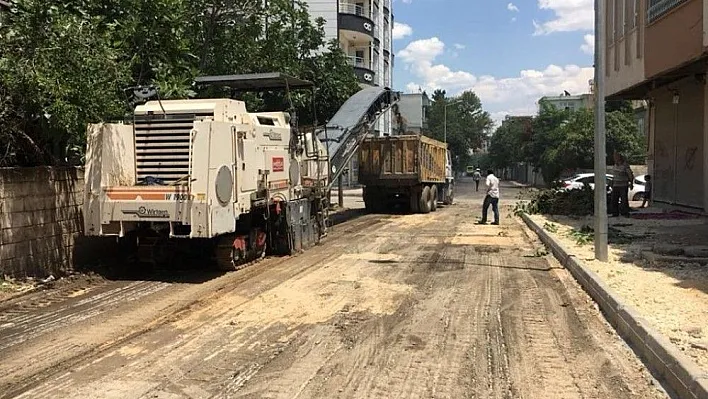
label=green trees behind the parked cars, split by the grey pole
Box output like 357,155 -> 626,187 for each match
490,99 -> 645,181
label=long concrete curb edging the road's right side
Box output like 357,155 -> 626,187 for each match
521,214 -> 708,399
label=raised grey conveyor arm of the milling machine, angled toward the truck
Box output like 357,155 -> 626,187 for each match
317,87 -> 400,187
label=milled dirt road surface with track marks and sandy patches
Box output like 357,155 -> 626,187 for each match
0,181 -> 666,399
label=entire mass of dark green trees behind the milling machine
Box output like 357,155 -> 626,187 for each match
0,0 -> 358,166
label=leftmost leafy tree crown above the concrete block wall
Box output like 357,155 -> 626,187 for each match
0,0 -> 129,165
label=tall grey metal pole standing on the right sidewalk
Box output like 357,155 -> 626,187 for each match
594,0 -> 608,262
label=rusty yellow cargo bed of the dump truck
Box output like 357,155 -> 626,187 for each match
359,135 -> 447,186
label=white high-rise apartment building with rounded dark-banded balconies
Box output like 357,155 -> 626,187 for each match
305,0 -> 394,134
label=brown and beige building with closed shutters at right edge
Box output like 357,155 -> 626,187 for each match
605,0 -> 708,212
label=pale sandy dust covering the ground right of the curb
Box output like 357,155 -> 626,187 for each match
531,215 -> 708,372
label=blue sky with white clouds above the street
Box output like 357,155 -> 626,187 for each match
393,0 -> 594,121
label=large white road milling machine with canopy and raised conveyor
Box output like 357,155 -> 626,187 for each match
84,73 -> 398,269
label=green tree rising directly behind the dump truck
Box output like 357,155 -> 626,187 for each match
424,90 -> 493,170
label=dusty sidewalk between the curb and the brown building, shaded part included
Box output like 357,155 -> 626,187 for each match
528,213 -> 708,397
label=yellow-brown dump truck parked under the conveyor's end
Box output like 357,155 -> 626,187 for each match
359,135 -> 455,213
